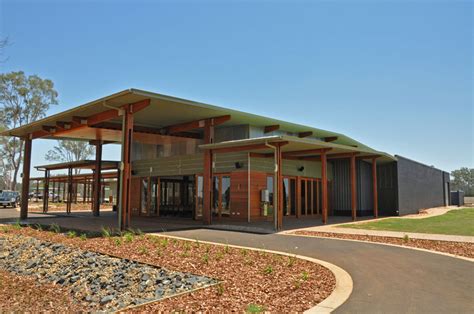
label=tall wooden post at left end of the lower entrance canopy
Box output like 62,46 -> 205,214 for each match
202,120 -> 214,225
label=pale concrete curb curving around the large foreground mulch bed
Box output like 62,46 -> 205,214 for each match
148,233 -> 354,314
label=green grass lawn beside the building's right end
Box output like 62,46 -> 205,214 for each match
341,208 -> 474,236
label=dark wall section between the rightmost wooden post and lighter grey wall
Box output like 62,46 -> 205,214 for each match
377,161 -> 398,216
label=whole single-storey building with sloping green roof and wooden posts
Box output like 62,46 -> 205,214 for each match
2,89 -> 449,230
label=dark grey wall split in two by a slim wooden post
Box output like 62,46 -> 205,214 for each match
331,158 -> 373,216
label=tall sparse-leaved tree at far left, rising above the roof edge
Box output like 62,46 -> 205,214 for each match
0,71 -> 58,190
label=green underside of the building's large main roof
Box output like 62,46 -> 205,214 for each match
0,89 -> 393,158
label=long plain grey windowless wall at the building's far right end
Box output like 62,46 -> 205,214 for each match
396,156 -> 449,215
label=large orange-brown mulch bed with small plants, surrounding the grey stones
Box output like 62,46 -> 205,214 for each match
0,226 -> 336,312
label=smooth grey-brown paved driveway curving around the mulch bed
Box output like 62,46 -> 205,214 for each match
166,229 -> 474,313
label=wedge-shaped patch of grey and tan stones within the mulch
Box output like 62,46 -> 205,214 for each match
0,235 -> 217,310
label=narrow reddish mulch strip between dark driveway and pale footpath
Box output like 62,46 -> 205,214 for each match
292,231 -> 474,258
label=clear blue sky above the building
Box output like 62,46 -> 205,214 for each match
0,0 -> 474,177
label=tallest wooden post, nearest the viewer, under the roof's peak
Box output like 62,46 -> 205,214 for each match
119,105 -> 133,230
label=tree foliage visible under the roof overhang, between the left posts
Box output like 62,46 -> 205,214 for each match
45,140 -> 94,174
